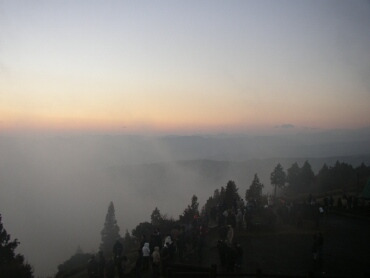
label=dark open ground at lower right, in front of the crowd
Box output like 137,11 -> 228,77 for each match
188,214 -> 370,277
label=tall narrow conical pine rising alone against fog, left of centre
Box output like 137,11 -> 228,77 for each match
99,202 -> 121,257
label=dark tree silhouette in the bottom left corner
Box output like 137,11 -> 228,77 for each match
0,214 -> 33,278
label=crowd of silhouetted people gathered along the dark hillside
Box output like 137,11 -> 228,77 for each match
88,194 -> 332,278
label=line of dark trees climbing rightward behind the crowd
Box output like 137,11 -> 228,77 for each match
56,161 -> 370,277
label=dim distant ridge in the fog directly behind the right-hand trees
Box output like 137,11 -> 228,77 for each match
109,154 -> 370,197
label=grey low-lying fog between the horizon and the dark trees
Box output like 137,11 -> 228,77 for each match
0,129 -> 370,277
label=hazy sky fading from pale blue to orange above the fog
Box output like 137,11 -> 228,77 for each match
0,0 -> 370,134
